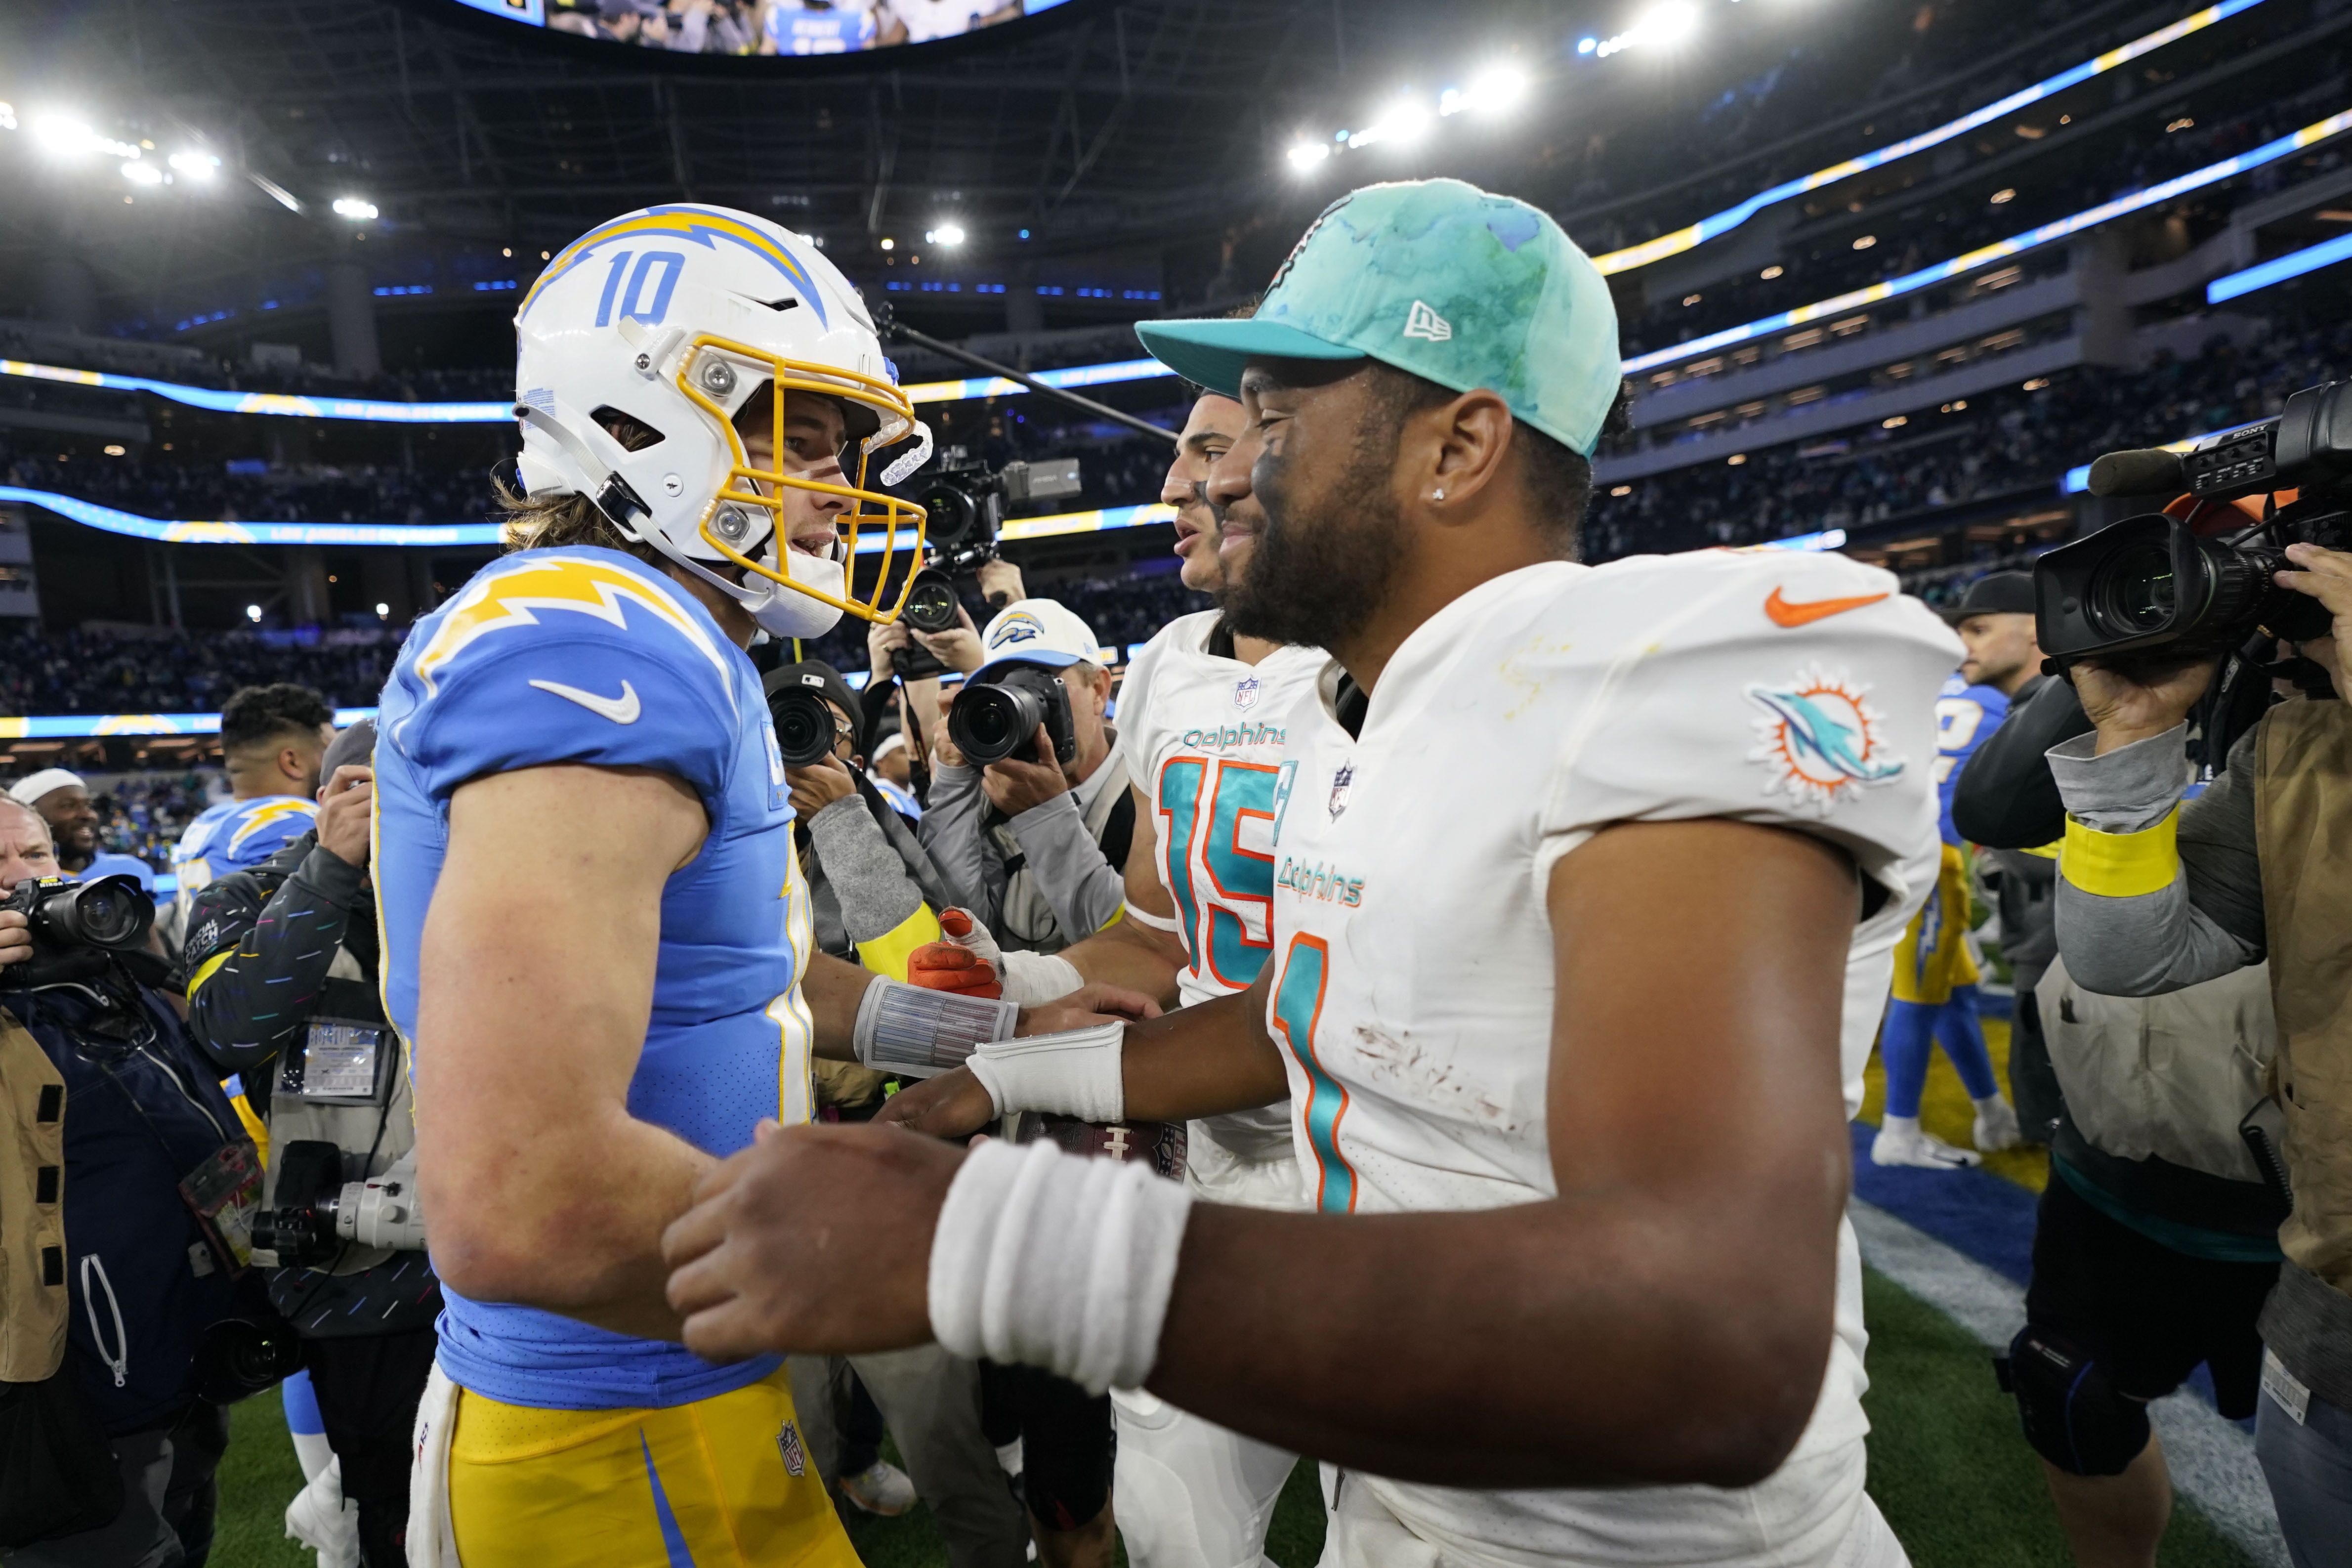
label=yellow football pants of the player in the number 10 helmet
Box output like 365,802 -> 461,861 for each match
449,1368 -> 858,1568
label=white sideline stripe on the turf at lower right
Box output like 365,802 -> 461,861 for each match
1853,1199 -> 2291,1568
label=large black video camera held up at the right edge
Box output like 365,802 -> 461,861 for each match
2034,381 -> 2352,668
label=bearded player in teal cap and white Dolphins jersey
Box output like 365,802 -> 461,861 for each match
666,181 -> 1959,1568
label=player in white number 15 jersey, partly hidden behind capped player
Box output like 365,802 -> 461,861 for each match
908,390 -> 1324,1568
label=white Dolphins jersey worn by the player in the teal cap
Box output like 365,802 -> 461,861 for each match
1268,550 -> 1959,1568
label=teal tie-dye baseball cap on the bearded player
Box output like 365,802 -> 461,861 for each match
1136,179 -> 1623,456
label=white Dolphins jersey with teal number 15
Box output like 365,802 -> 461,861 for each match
1117,609 -> 1329,1161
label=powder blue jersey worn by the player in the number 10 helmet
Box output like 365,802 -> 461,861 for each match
377,548 -> 811,1410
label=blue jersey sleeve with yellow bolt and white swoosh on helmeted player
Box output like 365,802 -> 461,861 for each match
390,552 -> 741,820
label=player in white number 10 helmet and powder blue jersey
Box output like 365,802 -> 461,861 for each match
377,207 -> 1143,1568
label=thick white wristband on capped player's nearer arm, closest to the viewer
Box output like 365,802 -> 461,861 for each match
929,1143 -> 1192,1394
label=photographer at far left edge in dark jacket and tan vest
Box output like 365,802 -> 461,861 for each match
0,799 -> 259,1568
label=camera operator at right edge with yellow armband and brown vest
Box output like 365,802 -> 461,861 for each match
2049,543 -> 2352,1563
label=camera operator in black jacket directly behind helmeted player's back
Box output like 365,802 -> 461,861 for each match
181,720 -> 442,1568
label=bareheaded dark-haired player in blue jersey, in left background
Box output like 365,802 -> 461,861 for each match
171,682 -> 334,924
